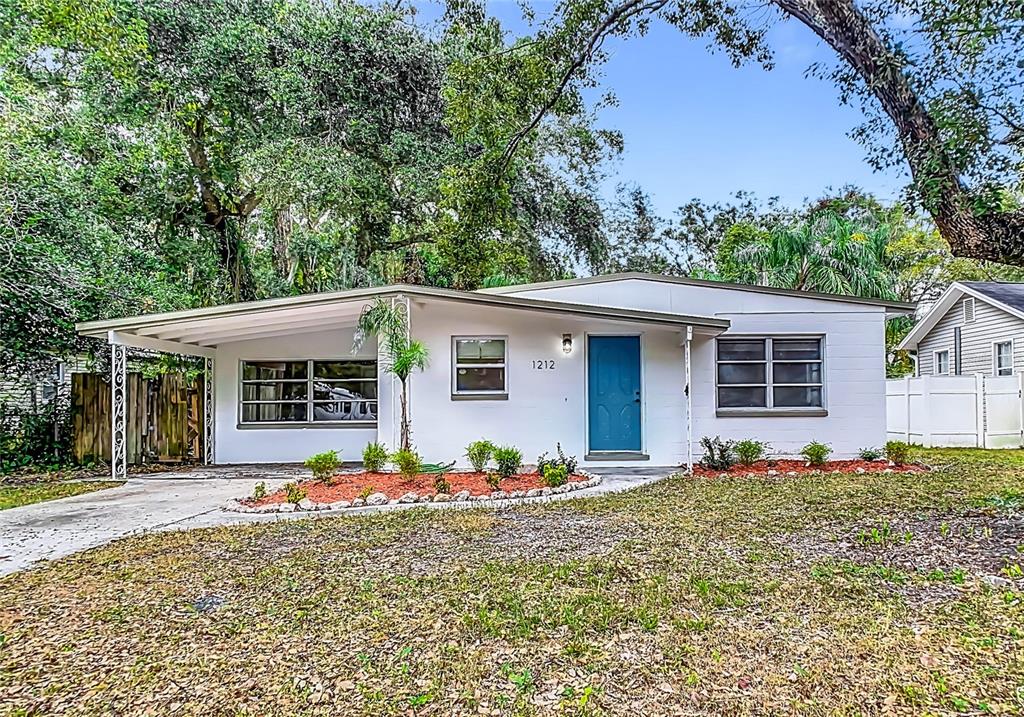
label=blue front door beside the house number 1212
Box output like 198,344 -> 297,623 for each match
587,336 -> 641,451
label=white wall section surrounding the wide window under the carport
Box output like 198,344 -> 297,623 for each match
214,329 -> 377,463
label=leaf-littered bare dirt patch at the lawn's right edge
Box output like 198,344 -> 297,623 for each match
782,510 -> 1024,582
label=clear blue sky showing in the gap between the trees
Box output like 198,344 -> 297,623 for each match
418,2 -> 906,216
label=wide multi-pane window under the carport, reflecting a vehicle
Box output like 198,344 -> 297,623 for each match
239,359 -> 377,425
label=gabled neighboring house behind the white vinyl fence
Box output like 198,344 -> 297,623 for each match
898,282 -> 1024,376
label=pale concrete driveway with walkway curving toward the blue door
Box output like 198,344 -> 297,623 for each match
0,465 -> 676,576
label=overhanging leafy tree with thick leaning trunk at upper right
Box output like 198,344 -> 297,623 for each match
460,0 -> 1024,265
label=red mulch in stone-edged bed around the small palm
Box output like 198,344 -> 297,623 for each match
243,471 -> 586,506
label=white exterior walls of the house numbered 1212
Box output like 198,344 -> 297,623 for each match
207,280 -> 886,466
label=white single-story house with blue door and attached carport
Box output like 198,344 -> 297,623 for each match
78,273 -> 913,473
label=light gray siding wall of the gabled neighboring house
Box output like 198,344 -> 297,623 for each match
918,296 -> 1024,376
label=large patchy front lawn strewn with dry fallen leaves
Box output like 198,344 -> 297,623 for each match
0,451 -> 1024,716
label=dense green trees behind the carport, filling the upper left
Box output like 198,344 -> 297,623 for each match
0,0 -> 621,372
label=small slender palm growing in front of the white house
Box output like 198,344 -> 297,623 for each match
352,298 -> 430,451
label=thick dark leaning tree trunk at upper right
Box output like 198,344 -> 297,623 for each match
774,0 -> 1024,265
